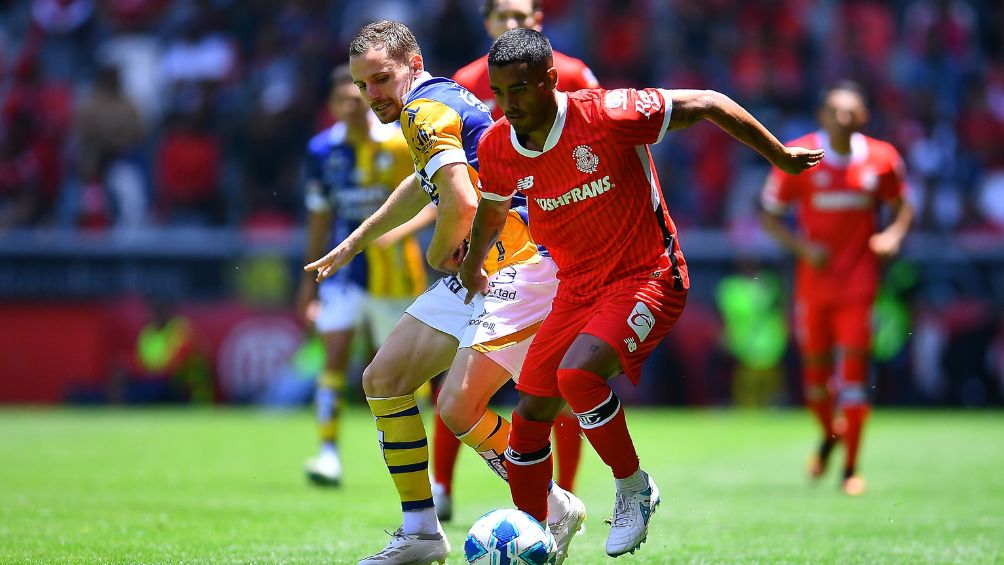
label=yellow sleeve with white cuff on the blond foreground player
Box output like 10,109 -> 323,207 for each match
401,98 -> 467,181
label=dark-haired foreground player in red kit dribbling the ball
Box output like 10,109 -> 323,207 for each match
460,29 -> 822,557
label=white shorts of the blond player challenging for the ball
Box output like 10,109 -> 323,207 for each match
408,257 -> 558,376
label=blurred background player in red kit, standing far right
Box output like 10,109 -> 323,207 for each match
762,83 -> 914,495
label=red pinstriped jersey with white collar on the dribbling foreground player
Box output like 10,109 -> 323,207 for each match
478,88 -> 690,302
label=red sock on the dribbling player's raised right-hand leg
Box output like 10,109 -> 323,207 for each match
558,368 -> 639,479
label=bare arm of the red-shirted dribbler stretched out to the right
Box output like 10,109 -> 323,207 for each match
668,90 -> 823,175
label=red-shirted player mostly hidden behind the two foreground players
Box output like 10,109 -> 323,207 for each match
433,0 -> 599,521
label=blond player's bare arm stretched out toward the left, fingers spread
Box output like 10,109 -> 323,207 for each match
303,174 -> 429,282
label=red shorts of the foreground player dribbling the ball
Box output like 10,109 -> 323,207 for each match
516,278 -> 687,396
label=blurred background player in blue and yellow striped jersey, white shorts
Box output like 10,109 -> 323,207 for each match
297,65 -> 435,485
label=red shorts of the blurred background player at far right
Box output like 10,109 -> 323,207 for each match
795,298 -> 872,354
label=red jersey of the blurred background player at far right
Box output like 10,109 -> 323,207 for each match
761,131 -> 907,300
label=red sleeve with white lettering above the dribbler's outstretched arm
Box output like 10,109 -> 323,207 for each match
599,88 -> 673,146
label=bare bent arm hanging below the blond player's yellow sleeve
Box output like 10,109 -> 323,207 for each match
426,163 -> 478,273
